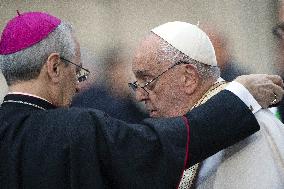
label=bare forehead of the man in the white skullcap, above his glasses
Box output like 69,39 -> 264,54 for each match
132,34 -> 168,76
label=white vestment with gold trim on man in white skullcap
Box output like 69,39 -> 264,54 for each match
179,81 -> 284,189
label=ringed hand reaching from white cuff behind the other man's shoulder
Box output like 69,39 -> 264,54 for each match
235,74 -> 284,108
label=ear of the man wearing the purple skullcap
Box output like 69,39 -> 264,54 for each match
46,53 -> 62,83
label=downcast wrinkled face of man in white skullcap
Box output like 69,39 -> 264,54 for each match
132,35 -> 189,117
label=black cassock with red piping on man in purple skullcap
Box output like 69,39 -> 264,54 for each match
0,91 -> 259,189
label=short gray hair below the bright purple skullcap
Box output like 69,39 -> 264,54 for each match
0,22 -> 76,86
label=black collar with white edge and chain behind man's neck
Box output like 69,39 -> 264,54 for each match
2,92 -> 56,110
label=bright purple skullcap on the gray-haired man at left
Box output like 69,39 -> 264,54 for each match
0,12 -> 61,55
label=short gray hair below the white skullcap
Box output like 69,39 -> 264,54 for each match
159,37 -> 220,82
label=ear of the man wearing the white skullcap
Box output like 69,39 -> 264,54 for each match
183,64 -> 200,95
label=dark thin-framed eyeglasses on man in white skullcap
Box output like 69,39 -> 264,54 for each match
128,61 -> 189,95
